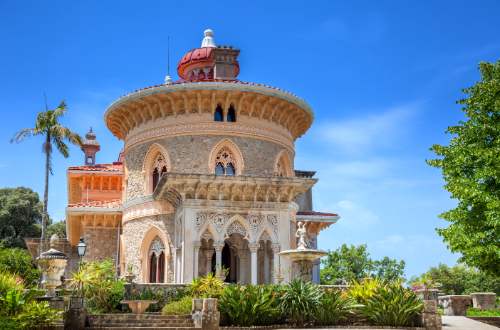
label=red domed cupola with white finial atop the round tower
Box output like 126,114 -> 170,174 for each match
177,29 -> 240,81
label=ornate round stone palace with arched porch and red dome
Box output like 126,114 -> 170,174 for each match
62,30 -> 339,284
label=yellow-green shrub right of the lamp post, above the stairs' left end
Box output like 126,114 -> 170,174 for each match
71,259 -> 125,313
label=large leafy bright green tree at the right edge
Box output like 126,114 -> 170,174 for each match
427,61 -> 500,276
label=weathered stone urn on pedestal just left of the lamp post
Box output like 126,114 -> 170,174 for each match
37,248 -> 68,297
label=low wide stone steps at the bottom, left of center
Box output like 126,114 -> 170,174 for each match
88,313 -> 194,330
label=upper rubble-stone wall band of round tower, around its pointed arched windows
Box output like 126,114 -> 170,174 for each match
125,135 -> 290,199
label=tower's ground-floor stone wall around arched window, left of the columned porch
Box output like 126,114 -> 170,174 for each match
122,214 -> 174,282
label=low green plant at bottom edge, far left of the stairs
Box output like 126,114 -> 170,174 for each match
16,301 -> 61,329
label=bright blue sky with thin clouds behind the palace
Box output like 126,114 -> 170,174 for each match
0,0 -> 500,277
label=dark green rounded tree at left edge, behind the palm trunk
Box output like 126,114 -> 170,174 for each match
0,187 -> 43,248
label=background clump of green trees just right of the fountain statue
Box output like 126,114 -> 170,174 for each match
320,244 -> 405,284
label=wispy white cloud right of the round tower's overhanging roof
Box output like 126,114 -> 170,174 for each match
317,103 -> 418,154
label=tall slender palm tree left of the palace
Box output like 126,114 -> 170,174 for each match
10,101 -> 82,253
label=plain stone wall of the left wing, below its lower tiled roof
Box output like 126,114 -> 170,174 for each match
83,227 -> 119,261
